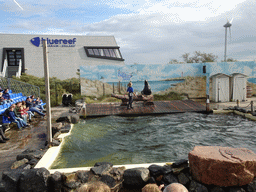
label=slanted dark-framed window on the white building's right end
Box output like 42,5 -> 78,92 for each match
84,47 -> 124,61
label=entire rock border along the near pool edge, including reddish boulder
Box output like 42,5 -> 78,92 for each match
0,146 -> 256,192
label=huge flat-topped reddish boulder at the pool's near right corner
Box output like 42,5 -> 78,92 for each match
189,146 -> 256,186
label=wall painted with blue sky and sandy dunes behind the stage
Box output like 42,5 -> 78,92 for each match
80,61 -> 256,98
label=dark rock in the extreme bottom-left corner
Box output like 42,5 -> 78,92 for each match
2,169 -> 30,192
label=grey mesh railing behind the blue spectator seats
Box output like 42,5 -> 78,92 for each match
0,77 -> 40,97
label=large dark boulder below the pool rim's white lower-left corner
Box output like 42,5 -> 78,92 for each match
20,168 -> 50,192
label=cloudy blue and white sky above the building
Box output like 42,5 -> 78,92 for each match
0,0 -> 256,64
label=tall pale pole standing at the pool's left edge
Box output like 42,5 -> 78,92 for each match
43,40 -> 52,144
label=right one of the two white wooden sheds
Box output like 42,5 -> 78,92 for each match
230,73 -> 247,101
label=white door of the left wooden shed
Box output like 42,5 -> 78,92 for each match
218,78 -> 229,102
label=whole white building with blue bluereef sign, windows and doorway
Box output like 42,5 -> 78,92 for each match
0,34 -> 124,79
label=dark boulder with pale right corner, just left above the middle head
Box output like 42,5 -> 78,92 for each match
123,167 -> 150,188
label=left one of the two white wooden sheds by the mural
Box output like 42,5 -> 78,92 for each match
210,73 -> 230,102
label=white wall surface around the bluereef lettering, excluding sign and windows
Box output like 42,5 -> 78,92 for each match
0,34 -> 124,79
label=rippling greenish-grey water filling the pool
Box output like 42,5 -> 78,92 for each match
51,113 -> 256,169
